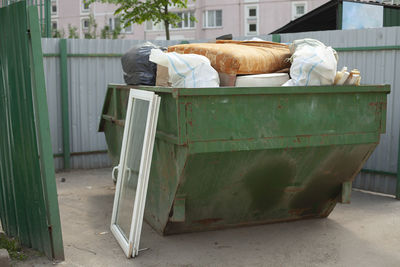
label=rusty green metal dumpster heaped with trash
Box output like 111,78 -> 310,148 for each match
99,84 -> 390,234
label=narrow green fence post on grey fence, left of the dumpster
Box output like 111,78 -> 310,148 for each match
59,39 -> 71,169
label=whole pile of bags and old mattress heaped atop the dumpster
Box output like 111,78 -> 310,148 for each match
122,38 -> 361,88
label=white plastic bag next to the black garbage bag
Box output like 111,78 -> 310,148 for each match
149,49 -> 219,88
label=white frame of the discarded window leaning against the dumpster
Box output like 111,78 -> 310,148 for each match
110,89 -> 161,258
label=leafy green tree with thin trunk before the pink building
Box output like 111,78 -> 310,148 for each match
85,0 -> 195,40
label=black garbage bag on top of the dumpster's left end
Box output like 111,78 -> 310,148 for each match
121,42 -> 166,86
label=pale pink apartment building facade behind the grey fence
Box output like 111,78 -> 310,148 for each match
51,0 -> 328,40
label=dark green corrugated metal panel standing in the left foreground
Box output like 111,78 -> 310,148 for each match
0,2 -> 64,259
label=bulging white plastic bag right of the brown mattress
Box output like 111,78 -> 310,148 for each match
283,39 -> 337,86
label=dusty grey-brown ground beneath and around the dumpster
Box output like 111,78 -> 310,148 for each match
15,169 -> 400,267
